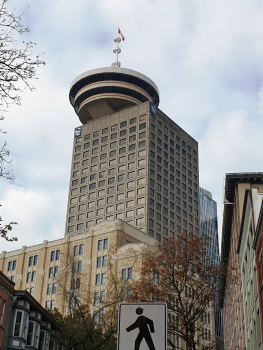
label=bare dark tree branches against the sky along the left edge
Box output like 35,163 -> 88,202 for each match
0,0 -> 45,241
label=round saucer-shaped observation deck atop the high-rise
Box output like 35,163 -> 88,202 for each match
69,67 -> 159,124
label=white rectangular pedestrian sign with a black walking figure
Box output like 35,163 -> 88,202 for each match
117,303 -> 167,350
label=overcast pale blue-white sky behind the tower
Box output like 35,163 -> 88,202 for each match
0,0 -> 263,252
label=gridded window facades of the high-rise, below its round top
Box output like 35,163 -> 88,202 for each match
67,110 -> 199,240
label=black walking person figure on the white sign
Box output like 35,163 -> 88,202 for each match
126,307 -> 155,350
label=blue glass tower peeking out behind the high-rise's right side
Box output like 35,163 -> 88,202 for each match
199,187 -> 223,338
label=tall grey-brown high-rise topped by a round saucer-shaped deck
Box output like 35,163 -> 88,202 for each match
65,67 -> 200,241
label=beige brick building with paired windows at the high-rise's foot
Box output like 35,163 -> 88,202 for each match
0,220 -> 156,314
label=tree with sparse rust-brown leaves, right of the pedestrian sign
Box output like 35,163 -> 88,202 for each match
131,233 -> 240,350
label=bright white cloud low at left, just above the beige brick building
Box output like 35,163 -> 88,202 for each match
0,185 -> 64,251
